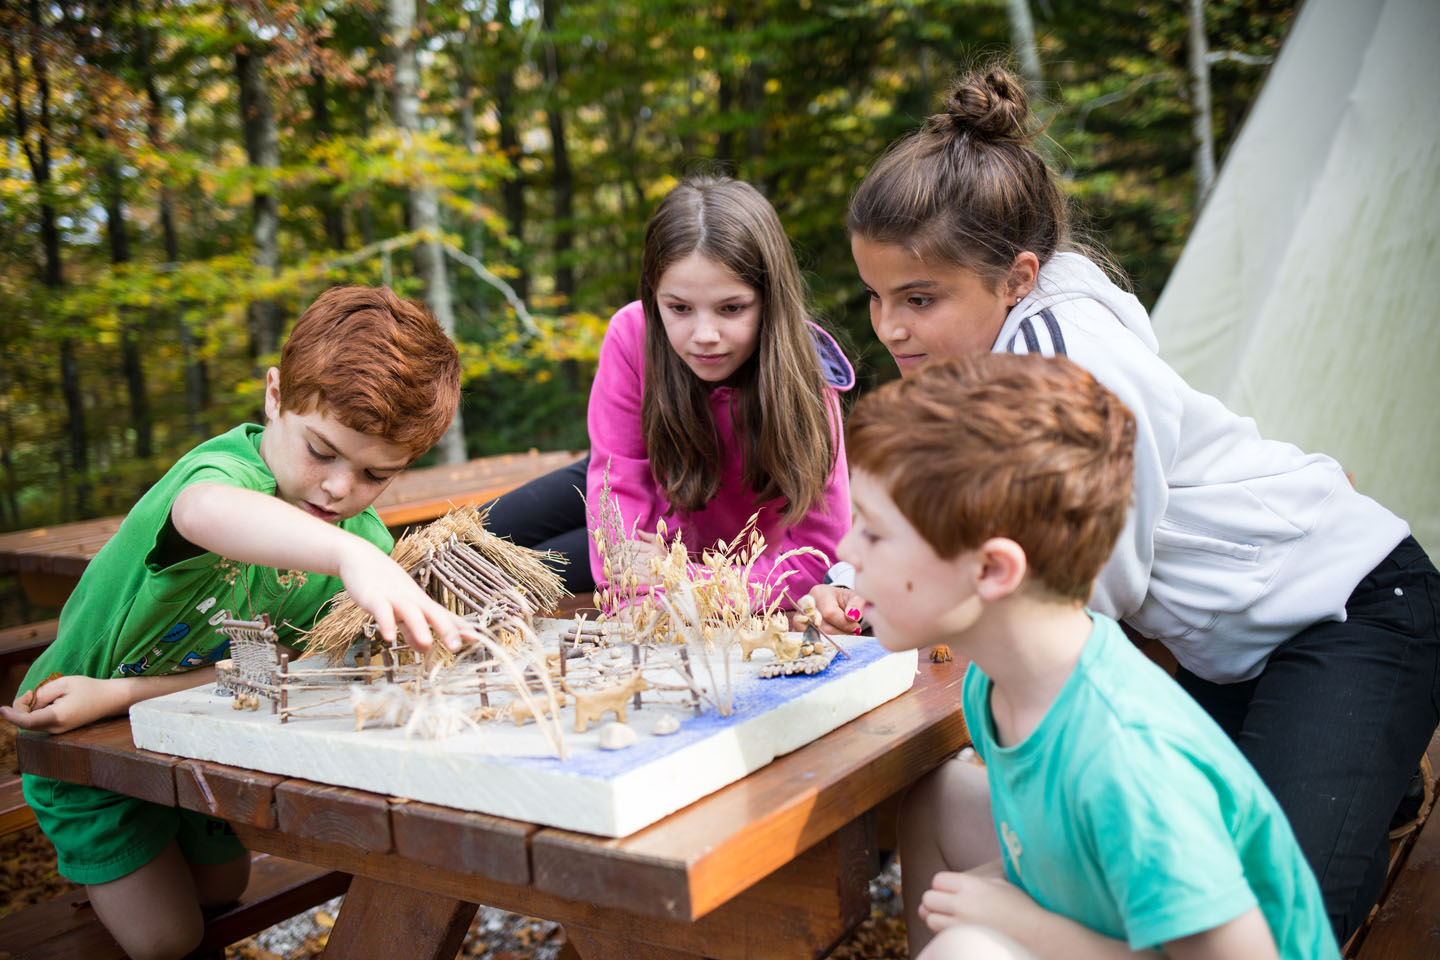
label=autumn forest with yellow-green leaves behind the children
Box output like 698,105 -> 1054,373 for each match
0,0 -> 1297,541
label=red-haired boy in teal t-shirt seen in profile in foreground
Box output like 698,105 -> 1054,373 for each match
840,354 -> 1339,960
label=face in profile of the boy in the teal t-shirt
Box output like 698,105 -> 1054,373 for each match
837,468 -> 976,651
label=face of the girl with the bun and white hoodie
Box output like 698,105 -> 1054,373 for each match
850,236 -> 1015,376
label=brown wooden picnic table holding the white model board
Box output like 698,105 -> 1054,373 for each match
17,656 -> 969,960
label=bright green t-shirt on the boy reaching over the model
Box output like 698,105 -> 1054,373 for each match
22,423 -> 395,689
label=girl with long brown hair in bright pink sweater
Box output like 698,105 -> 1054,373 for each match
491,177 -> 854,607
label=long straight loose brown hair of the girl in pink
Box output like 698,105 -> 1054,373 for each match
639,177 -> 840,524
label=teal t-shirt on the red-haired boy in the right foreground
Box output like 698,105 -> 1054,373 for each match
963,613 -> 1339,960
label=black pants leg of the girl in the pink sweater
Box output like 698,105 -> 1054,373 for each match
485,456 -> 595,594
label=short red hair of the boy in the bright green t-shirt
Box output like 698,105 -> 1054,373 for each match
279,286 -> 459,456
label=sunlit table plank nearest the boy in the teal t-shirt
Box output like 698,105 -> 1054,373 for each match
531,656 -> 969,920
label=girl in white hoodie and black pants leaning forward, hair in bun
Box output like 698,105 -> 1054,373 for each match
816,69 -> 1440,943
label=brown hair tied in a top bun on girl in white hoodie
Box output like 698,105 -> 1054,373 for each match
845,66 -> 1088,291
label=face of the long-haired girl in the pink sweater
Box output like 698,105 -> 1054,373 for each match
655,250 -> 760,383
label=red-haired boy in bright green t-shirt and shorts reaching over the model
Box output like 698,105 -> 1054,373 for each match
0,286 -> 469,957
